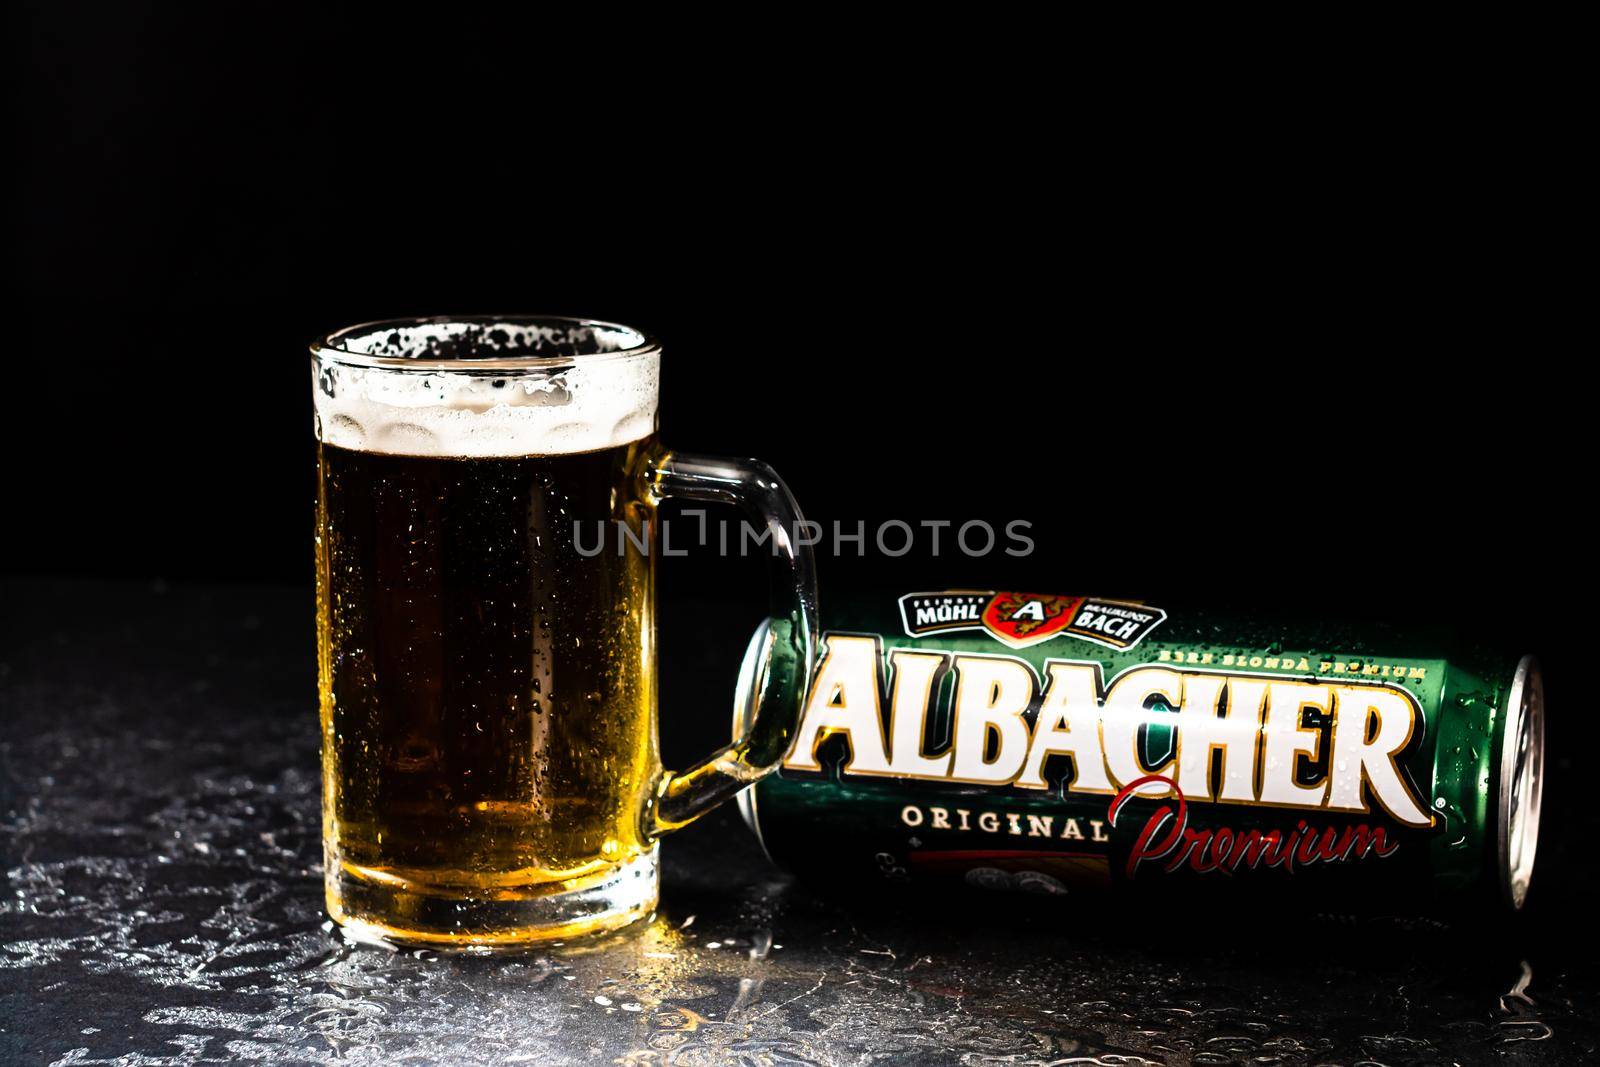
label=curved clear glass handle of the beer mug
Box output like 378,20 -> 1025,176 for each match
645,451 -> 818,835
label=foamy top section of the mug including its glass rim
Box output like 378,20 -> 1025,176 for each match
312,322 -> 661,458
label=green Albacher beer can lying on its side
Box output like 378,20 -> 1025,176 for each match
734,590 -> 1544,910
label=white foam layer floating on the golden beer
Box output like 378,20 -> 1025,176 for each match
312,325 -> 661,458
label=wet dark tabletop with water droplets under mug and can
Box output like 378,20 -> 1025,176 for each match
0,581 -> 1600,1065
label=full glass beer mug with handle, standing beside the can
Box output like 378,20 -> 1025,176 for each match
312,317 -> 816,947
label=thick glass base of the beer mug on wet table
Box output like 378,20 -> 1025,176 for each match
326,846 -> 661,952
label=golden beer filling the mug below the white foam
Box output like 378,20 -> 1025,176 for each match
317,437 -> 661,941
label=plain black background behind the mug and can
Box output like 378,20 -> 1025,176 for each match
12,16 -> 1589,739
